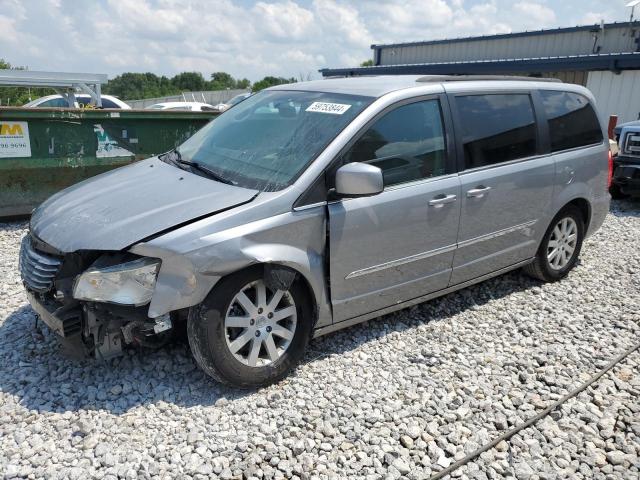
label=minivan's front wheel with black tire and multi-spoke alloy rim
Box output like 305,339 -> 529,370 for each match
187,267 -> 313,388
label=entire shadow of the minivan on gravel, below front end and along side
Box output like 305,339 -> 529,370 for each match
0,272 -> 539,415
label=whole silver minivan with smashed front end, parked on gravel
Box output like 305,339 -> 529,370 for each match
20,76 -> 611,387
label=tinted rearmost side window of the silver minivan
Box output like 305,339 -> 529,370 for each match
540,90 -> 603,152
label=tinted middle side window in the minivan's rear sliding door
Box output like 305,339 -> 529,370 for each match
456,94 -> 537,169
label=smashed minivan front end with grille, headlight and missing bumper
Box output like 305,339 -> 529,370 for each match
19,234 -> 172,359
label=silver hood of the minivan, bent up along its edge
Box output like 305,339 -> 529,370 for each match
31,158 -> 258,252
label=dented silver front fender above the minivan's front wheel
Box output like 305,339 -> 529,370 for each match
130,207 -> 332,327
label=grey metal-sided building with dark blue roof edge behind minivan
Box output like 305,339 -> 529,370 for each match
320,22 -> 640,121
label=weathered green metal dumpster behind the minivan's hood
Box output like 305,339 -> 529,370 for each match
0,107 -> 217,217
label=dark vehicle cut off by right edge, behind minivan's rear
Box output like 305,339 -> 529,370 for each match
611,121 -> 640,198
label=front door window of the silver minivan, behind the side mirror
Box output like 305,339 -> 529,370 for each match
344,100 -> 447,186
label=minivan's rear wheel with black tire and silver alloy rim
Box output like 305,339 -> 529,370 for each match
523,205 -> 585,282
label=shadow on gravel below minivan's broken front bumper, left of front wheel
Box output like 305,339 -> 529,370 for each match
0,305 -> 252,414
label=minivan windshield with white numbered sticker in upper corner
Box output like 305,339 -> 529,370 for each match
178,90 -> 373,192
